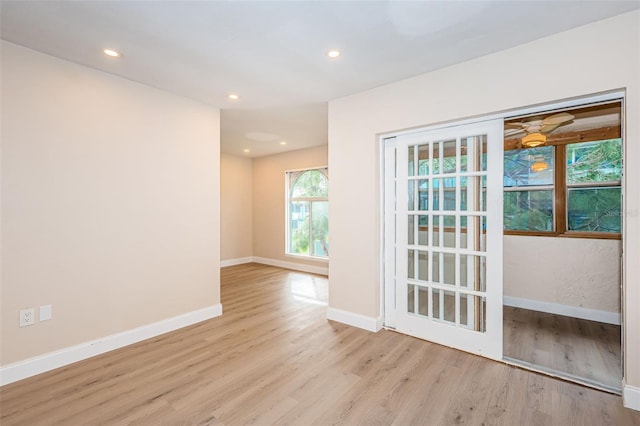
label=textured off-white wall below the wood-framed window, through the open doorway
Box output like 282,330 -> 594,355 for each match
503,235 -> 621,313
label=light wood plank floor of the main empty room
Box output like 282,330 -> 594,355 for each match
0,264 -> 640,426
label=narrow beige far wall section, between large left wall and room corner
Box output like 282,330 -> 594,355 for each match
220,154 -> 253,261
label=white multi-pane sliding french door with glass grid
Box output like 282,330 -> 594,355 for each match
384,119 -> 503,359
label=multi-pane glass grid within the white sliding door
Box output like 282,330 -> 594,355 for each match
407,137 -> 487,332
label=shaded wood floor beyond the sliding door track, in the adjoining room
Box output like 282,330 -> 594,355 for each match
504,306 -> 622,391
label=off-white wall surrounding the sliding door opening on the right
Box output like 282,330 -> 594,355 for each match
329,11 -> 640,386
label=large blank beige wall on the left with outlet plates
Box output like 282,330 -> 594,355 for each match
0,42 -> 220,365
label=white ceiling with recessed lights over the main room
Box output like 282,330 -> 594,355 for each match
0,0 -> 640,156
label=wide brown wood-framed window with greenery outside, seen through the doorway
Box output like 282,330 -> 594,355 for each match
504,138 -> 622,238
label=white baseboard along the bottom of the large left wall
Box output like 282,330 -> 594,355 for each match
0,303 -> 222,386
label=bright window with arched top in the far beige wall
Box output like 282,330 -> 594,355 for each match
286,167 -> 329,258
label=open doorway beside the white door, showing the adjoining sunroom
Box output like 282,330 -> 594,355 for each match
503,100 -> 623,393
